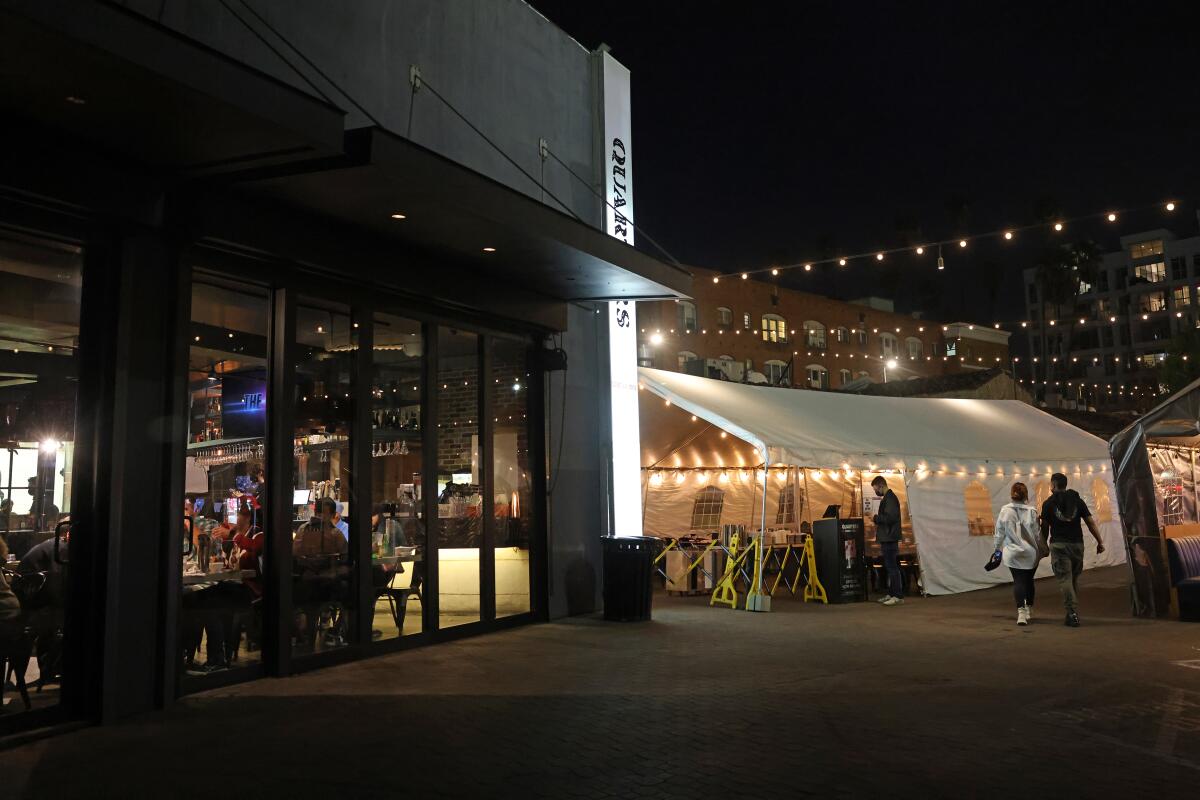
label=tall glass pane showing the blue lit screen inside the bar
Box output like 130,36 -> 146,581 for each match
173,276 -> 270,679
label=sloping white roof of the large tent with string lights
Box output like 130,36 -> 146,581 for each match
638,367 -> 1109,471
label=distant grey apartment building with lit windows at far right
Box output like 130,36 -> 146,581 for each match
1021,217 -> 1200,410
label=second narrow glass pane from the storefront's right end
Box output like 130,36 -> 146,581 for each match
436,327 -> 484,627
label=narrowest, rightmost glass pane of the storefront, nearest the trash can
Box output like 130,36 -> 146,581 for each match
491,338 -> 536,616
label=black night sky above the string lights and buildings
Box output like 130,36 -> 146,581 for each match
532,0 -> 1200,320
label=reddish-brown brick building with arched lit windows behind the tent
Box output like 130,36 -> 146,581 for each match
637,269 -> 1012,389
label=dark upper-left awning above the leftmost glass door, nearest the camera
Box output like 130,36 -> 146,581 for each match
0,0 -> 344,176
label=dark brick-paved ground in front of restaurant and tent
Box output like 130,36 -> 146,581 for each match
0,569 -> 1200,800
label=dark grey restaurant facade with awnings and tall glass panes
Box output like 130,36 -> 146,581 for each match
0,0 -> 690,735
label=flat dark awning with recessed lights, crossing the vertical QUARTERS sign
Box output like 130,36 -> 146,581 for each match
235,127 -> 691,300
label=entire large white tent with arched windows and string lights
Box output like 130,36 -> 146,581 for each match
638,368 -> 1124,594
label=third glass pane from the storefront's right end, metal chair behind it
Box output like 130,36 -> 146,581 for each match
371,314 -> 426,639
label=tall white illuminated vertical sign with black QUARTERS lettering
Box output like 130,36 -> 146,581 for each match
599,48 -> 642,536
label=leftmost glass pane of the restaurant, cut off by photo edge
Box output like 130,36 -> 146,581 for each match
0,234 -> 82,718
